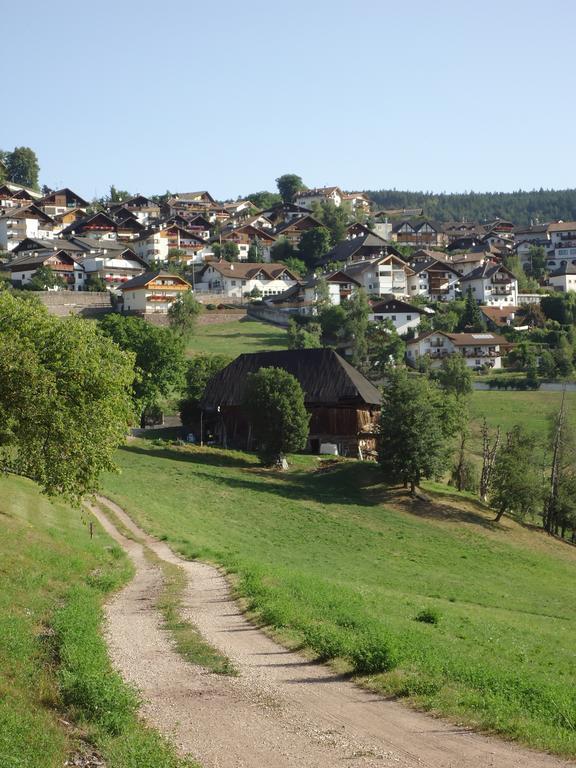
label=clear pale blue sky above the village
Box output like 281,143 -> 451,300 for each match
0,0 -> 576,199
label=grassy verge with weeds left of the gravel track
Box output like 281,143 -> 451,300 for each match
0,476 -> 196,768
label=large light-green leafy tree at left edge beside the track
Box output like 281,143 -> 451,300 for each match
0,292 -> 134,501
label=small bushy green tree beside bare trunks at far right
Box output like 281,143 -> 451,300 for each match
490,425 -> 543,522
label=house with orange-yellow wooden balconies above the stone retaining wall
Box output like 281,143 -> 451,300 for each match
120,271 -> 192,315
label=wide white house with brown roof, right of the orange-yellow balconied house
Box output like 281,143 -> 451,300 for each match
196,259 -> 298,299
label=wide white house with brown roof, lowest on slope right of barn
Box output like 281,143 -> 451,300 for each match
406,331 -> 509,370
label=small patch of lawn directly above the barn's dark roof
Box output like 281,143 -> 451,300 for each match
187,318 -> 286,357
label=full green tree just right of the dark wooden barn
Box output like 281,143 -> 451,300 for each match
379,368 -> 456,493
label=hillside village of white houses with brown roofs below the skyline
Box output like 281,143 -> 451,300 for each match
0,175 -> 576,380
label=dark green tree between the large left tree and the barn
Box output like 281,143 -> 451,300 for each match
100,314 -> 185,425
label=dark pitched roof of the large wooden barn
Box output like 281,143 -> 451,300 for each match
201,349 -> 382,408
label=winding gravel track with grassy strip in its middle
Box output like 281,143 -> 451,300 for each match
91,499 -> 575,768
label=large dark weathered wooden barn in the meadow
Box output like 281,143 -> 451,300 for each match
200,349 -> 381,456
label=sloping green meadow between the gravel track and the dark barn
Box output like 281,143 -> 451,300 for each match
105,441 -> 576,755
